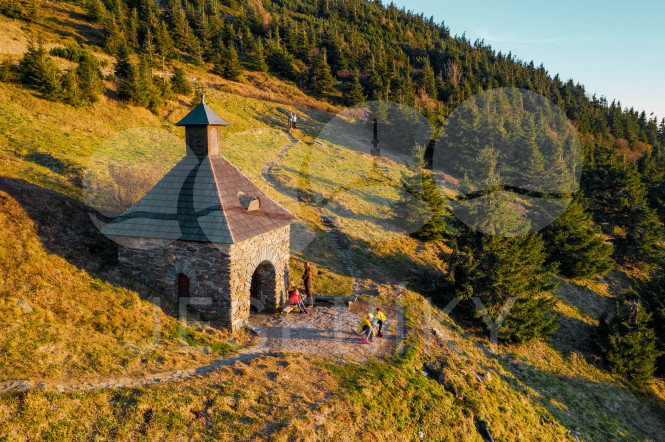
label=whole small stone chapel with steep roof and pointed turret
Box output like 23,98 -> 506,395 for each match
102,96 -> 298,330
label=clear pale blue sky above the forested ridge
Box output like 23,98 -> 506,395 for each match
383,0 -> 665,121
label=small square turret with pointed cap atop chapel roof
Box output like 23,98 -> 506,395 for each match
176,94 -> 229,160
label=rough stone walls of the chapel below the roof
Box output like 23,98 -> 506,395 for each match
118,226 -> 290,330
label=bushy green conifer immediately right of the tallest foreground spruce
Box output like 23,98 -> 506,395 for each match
543,201 -> 614,278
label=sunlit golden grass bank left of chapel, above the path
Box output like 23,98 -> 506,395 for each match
0,192 -> 231,383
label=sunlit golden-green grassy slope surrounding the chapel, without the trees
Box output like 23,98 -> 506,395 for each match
0,2 -> 665,441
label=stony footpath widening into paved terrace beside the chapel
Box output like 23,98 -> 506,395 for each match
0,131 -> 401,394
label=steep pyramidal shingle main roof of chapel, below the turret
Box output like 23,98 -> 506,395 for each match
102,155 -> 298,244
